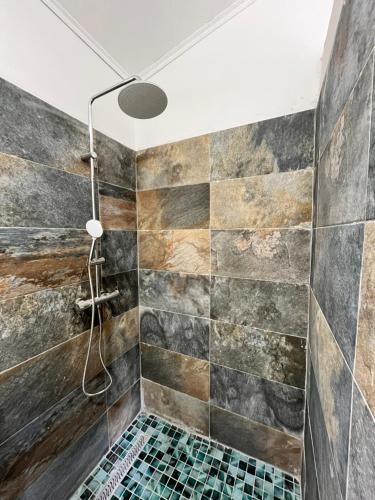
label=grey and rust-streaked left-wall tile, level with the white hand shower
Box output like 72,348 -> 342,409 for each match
0,227 -> 91,299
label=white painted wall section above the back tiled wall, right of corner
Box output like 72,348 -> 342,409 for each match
135,0 -> 332,149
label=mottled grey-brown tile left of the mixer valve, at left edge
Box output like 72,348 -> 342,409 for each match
0,284 -> 91,371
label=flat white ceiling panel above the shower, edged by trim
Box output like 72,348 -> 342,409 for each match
53,0 -> 239,75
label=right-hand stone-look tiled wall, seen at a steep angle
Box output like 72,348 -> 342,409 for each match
303,0 -> 375,500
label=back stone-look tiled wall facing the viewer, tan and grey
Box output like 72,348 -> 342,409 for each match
137,111 -> 314,474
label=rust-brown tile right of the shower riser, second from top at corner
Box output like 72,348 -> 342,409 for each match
99,182 -> 137,231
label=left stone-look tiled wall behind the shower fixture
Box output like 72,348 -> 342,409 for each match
0,80 -> 140,500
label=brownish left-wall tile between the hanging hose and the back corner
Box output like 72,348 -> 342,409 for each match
103,307 -> 139,364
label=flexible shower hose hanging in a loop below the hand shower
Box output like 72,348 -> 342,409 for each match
82,237 -> 112,397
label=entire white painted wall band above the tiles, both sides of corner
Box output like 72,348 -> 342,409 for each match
0,0 -> 333,149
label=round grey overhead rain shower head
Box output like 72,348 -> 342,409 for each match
118,81 -> 168,120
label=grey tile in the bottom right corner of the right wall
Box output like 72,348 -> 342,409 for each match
347,385 -> 375,500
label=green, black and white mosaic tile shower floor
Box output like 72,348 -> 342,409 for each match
71,414 -> 300,500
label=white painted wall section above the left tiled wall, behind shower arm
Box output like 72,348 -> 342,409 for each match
0,0 -> 135,148
